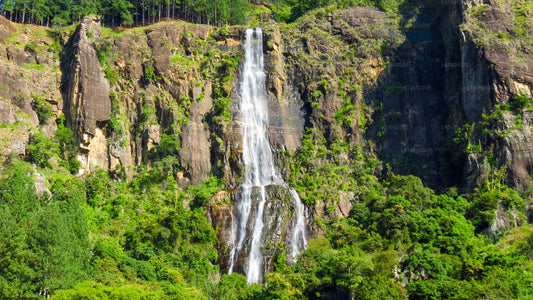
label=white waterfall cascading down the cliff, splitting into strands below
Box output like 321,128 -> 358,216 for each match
228,28 -> 307,283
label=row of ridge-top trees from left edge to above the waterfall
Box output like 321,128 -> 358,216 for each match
0,0 -> 249,26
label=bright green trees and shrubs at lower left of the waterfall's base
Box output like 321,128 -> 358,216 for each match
0,157 -> 217,299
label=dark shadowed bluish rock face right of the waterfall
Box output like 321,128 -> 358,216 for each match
365,4 -> 464,189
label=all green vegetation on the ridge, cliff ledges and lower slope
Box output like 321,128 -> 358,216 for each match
0,0 -> 533,299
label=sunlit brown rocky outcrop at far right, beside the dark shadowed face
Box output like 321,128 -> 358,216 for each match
460,1 -> 533,190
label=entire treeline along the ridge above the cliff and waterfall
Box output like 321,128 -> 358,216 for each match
0,0 -> 403,27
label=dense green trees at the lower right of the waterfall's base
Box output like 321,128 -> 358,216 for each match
261,176 -> 533,299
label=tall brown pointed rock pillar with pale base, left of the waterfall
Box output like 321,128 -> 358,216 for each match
63,17 -> 111,174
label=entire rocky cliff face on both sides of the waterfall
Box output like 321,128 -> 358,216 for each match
0,3 -> 532,195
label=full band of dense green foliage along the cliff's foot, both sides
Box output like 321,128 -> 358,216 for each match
0,151 -> 533,299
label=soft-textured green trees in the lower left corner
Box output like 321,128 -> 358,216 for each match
0,161 -> 91,299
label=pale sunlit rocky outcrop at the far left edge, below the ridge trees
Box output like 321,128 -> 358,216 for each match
0,16 -> 63,161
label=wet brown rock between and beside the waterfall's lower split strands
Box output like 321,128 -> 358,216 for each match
208,185 -> 308,274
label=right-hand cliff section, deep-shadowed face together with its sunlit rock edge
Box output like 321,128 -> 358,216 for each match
328,1 -> 533,192
